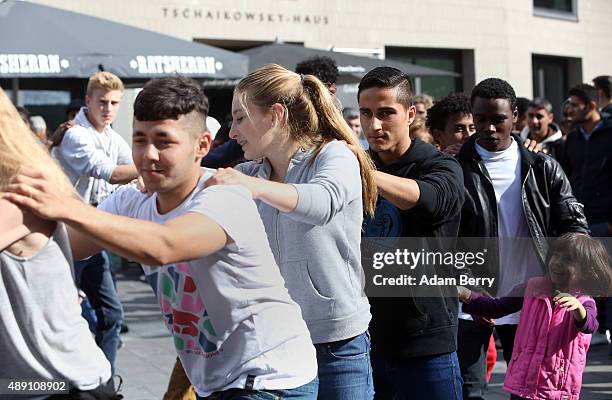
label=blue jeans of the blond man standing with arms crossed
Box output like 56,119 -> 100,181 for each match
74,252 -> 123,376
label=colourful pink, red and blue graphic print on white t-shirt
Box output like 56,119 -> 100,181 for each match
145,263 -> 218,357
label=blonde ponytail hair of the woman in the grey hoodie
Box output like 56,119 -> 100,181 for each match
234,64 -> 378,215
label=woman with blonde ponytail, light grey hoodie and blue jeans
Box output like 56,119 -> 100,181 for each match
210,65 -> 377,400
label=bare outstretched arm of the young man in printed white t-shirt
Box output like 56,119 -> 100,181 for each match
2,170 -> 228,265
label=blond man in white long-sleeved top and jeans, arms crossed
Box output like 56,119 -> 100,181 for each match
53,72 -> 138,374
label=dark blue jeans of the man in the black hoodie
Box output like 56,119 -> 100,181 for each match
372,351 -> 463,400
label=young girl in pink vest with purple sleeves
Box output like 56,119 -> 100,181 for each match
458,233 -> 612,400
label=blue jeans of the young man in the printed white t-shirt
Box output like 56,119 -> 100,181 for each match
196,378 -> 319,400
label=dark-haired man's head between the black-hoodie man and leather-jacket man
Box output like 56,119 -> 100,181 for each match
427,92 -> 475,155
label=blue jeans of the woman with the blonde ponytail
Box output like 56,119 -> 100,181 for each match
315,332 -> 374,400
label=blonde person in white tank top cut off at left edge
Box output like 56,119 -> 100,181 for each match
0,89 -> 116,399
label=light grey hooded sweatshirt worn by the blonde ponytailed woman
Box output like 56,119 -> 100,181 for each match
236,141 -> 372,344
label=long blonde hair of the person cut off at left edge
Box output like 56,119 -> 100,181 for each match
0,88 -> 77,196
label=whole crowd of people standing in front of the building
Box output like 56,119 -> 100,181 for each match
0,58 -> 612,400
